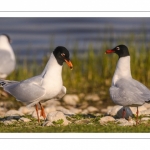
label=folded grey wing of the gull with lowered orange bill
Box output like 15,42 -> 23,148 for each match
4,78 -> 45,104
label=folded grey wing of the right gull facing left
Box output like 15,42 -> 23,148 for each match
110,79 -> 150,106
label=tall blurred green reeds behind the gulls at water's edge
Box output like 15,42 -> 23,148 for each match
7,39 -> 150,99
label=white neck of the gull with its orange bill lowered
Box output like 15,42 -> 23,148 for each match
41,53 -> 62,79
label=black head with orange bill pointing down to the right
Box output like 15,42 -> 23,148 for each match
53,46 -> 73,69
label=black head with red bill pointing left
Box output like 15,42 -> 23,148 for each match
106,45 -> 130,58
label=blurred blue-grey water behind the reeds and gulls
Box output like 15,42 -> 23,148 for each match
0,17 -> 150,60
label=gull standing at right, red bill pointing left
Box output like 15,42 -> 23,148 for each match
106,45 -> 150,123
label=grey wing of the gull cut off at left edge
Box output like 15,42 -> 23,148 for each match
0,50 -> 16,74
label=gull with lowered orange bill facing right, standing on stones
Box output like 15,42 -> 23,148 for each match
0,46 -> 73,122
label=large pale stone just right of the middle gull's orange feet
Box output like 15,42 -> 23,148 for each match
46,111 -> 69,125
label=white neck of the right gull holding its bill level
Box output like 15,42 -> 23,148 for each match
112,56 -> 132,85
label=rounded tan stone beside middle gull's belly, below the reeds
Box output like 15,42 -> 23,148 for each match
63,94 -> 79,106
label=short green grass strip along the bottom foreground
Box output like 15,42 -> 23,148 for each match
0,115 -> 150,133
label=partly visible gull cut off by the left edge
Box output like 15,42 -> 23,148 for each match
0,34 -> 16,79
